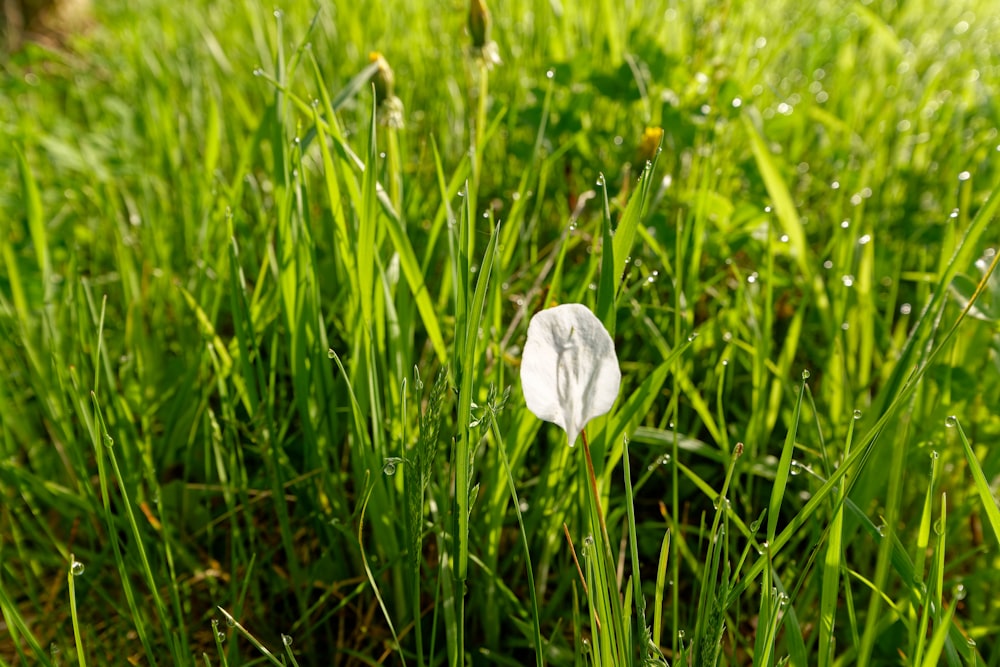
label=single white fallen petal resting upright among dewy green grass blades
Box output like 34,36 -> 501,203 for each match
521,303 -> 622,447
